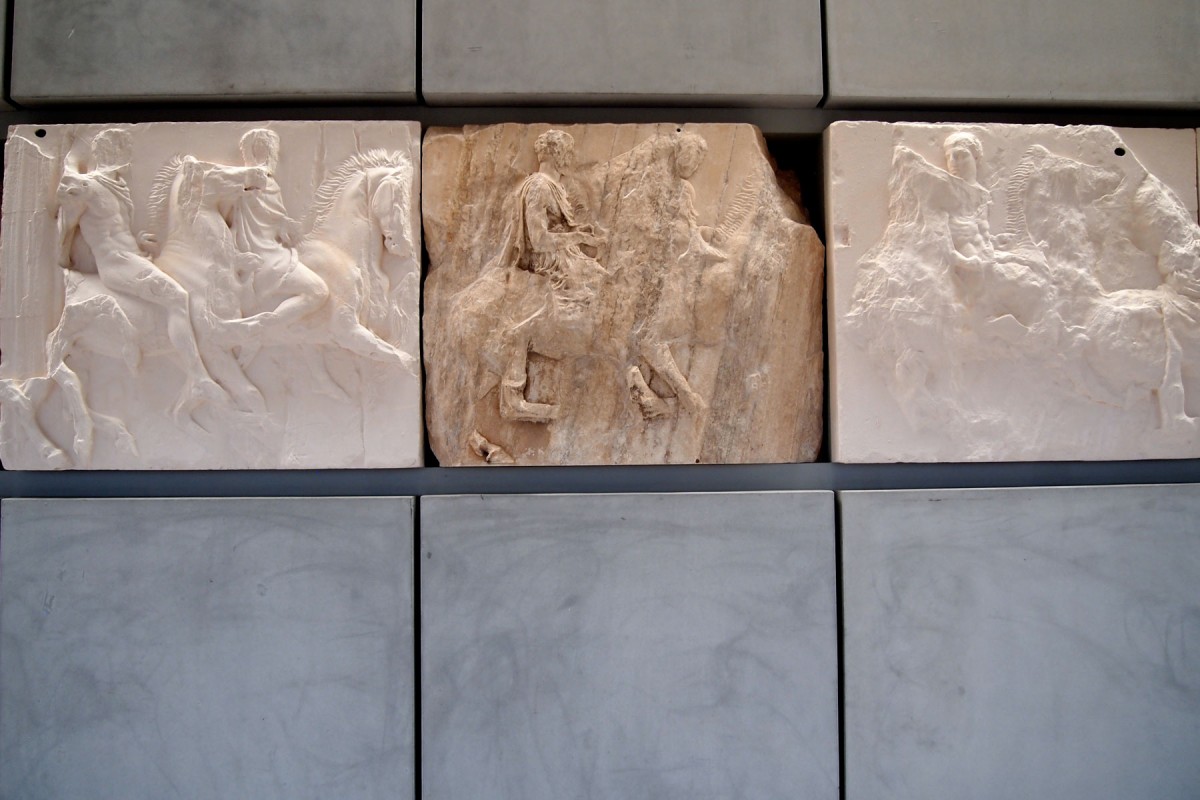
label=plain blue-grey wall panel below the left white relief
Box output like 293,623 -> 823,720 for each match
0,498 -> 414,800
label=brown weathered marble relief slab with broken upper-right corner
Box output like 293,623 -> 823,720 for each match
421,125 -> 823,465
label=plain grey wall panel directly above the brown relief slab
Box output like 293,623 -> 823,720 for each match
421,0 -> 823,108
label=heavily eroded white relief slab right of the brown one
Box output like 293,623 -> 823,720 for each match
826,122 -> 1200,462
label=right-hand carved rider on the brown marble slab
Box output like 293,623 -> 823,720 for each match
625,132 -> 727,419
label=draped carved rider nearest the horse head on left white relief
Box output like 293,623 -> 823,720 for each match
215,128 -> 329,332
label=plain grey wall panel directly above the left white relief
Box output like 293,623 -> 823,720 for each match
12,0 -> 416,104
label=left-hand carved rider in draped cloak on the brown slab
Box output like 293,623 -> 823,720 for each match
499,131 -> 608,422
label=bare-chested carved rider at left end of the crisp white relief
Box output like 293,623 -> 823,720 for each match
56,128 -> 228,414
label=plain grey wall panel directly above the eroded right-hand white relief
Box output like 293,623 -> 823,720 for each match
826,0 -> 1200,107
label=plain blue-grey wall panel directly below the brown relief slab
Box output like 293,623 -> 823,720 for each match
420,492 -> 839,800
